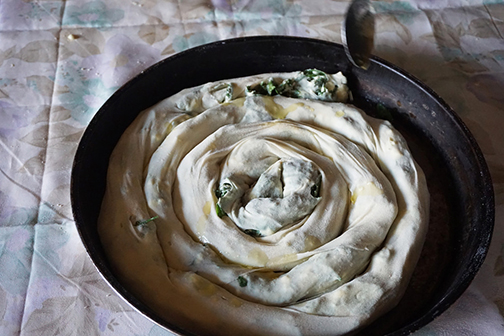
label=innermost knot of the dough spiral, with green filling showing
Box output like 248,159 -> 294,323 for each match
216,154 -> 321,237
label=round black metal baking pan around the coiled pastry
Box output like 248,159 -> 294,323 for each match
71,36 -> 494,336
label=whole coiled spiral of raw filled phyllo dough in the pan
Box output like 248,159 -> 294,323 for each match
99,69 -> 429,335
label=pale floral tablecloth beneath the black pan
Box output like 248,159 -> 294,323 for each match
0,0 -> 504,336
